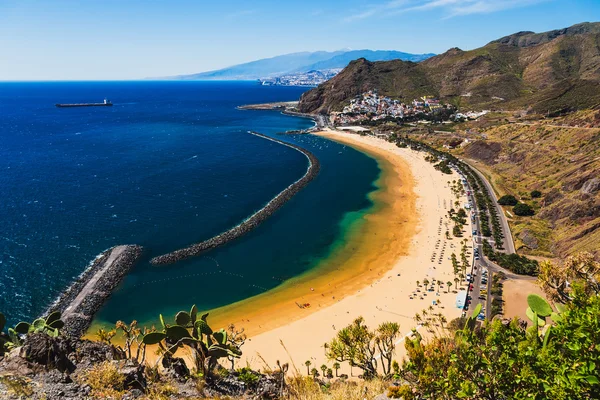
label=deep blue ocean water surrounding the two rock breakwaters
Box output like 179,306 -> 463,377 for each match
0,82 -> 379,323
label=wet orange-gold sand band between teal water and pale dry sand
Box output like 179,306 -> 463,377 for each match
202,131 -> 418,336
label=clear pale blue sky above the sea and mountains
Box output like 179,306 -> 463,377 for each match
0,0 -> 600,81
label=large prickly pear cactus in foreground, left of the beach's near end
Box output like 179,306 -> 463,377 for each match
142,305 -> 242,374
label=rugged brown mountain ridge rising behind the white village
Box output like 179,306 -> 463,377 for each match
299,23 -> 600,113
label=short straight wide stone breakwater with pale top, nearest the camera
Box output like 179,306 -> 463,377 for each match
46,245 -> 143,337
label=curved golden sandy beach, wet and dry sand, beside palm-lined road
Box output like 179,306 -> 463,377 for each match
229,131 -> 471,375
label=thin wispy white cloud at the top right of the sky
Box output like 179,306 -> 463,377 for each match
344,0 -> 549,22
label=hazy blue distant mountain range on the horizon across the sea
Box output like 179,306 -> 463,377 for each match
169,50 -> 435,80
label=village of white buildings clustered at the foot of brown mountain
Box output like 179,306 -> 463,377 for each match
330,90 -> 488,126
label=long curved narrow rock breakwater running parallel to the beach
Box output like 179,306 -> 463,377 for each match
150,132 -> 321,265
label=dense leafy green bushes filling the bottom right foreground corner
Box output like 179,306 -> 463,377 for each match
401,268 -> 600,400
